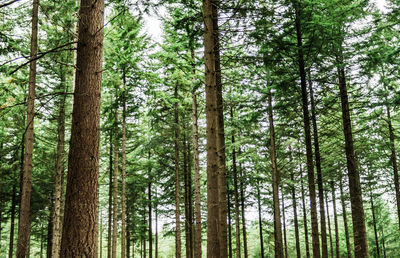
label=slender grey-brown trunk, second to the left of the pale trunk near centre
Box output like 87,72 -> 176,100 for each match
174,85 -> 181,258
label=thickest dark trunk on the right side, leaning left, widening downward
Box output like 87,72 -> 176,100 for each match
338,62 -> 369,258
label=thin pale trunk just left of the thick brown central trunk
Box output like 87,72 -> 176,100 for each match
192,90 -> 201,258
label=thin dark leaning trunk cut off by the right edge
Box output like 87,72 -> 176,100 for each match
386,105 -> 400,231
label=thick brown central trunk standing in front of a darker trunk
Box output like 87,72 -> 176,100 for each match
203,0 -> 227,258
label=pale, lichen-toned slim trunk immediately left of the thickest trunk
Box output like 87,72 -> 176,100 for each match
51,70 -> 67,258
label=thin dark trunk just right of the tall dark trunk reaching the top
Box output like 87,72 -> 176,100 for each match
308,71 -> 332,258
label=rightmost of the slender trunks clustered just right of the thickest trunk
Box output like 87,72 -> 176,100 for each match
121,71 -> 127,258
